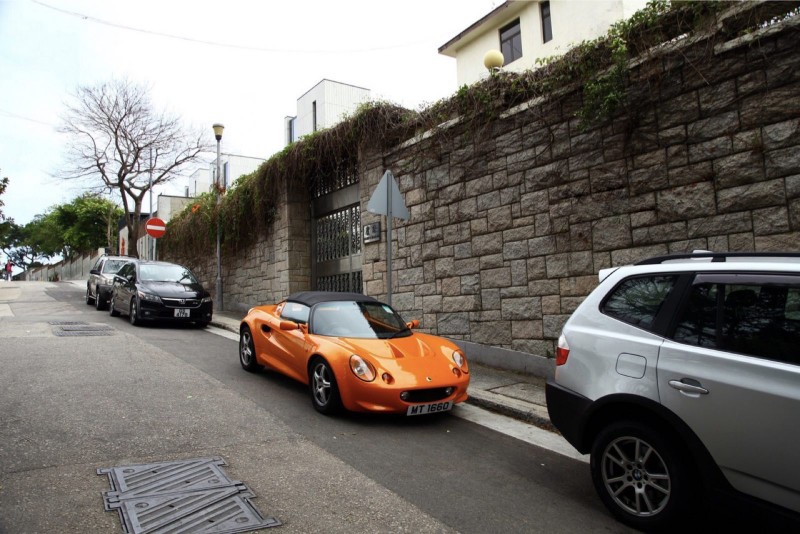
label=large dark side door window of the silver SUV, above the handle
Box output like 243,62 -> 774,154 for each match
673,276 -> 800,364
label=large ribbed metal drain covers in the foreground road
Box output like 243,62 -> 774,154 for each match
97,457 -> 281,534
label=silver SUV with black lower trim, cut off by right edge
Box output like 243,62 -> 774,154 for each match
547,251 -> 800,530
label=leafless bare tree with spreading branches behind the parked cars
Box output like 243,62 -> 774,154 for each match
60,80 -> 209,256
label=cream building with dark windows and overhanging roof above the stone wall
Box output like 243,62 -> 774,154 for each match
439,0 -> 647,86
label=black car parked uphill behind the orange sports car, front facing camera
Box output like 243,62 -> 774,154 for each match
109,260 -> 213,328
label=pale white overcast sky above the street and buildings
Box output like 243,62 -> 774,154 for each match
0,0 -> 501,224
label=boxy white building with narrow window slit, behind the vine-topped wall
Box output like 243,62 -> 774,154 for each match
284,80 -> 370,145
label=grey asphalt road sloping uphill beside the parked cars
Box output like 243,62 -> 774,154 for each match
0,283 -> 796,534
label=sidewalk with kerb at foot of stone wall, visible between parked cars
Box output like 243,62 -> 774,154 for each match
211,312 -> 555,431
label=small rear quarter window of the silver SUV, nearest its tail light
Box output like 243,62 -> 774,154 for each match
600,275 -> 678,330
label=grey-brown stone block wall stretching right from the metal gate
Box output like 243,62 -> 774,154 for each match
362,15 -> 800,364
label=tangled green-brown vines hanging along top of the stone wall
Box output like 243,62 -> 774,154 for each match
161,0 -> 800,257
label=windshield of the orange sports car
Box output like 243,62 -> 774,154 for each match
311,301 -> 411,339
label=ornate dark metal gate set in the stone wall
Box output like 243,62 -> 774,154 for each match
311,161 -> 363,293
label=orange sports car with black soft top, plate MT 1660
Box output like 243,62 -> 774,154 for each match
239,291 -> 469,415
